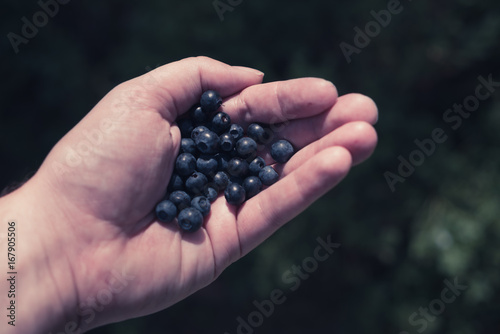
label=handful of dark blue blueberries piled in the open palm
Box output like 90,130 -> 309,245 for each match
155,90 -> 294,232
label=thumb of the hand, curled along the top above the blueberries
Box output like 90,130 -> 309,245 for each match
118,57 -> 264,121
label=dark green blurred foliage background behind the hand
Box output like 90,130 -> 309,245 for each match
0,0 -> 500,334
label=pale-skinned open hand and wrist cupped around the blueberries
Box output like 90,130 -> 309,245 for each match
0,57 -> 377,333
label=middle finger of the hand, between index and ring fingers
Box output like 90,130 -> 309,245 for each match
276,94 -> 378,148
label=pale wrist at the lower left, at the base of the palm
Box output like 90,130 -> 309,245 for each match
0,177 -> 78,334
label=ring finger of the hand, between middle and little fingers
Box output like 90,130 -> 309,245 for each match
274,122 -> 377,172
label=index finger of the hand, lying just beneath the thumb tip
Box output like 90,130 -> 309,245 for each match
222,78 -> 337,126
